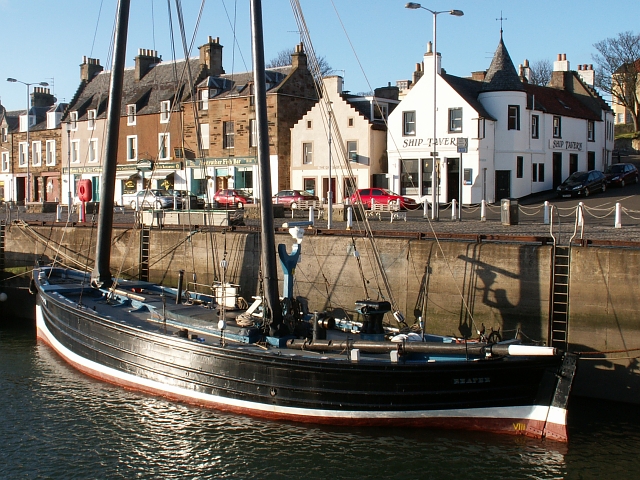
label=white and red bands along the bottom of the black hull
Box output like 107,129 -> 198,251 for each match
36,305 -> 567,442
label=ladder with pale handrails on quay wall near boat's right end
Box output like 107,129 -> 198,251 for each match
548,206 -> 584,351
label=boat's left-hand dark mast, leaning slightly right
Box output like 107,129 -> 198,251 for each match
91,0 -> 131,288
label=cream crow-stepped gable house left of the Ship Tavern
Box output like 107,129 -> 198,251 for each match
291,76 -> 398,202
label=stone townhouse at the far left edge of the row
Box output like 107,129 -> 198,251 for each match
0,87 -> 66,203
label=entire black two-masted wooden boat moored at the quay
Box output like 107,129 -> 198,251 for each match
33,0 -> 576,441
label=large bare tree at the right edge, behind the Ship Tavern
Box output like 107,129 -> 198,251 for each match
593,32 -> 640,132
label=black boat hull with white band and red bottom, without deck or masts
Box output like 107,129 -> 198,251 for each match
36,274 -> 570,441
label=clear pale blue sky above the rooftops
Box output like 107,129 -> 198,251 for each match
0,0 -> 640,110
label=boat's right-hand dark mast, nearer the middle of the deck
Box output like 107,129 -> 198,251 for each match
251,0 -> 283,336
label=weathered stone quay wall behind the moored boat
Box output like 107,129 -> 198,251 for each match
5,224 -> 640,403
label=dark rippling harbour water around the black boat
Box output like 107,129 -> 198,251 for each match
0,328 -> 640,480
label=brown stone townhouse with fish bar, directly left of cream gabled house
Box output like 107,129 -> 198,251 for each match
183,40 -> 318,201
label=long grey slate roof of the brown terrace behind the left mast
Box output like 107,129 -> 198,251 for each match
67,58 -> 203,121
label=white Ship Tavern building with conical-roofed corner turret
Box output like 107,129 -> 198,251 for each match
387,38 -> 613,204
